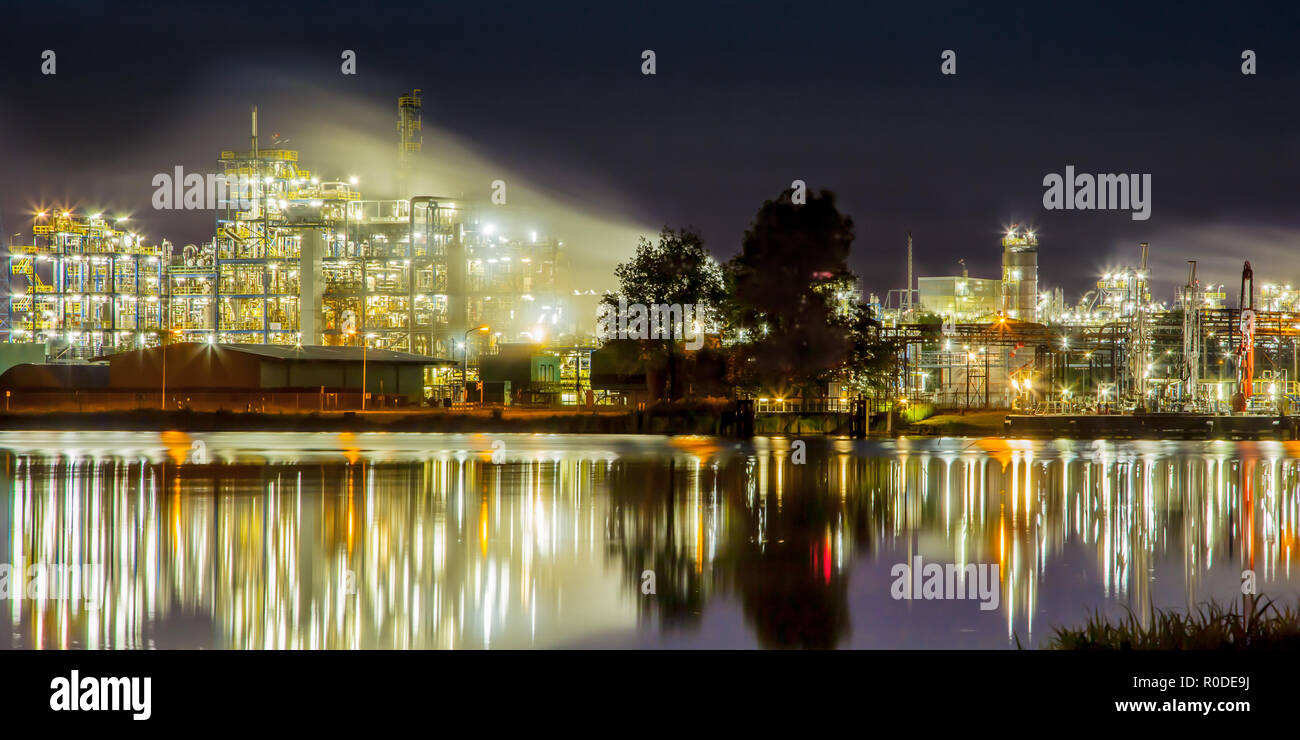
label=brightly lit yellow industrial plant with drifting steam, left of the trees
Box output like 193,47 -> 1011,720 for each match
7,90 -> 568,366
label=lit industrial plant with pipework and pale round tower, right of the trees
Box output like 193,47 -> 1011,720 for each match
874,225 -> 1300,423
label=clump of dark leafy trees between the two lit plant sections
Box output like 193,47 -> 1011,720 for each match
605,190 -> 894,398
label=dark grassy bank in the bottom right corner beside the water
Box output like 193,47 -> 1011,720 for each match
1047,597 -> 1300,650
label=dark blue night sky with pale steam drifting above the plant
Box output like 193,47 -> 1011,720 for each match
0,0 -> 1300,302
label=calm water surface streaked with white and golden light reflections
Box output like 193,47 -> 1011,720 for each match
0,432 -> 1300,649
